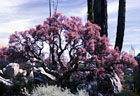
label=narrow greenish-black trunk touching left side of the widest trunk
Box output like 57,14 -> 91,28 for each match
87,0 -> 94,23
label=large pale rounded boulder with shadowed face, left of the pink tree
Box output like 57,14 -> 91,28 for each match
3,63 -> 19,79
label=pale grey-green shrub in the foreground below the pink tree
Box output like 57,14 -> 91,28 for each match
31,86 -> 88,96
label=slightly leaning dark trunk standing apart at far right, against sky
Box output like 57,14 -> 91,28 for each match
115,0 -> 126,51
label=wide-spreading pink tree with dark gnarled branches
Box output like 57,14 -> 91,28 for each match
9,13 -> 137,92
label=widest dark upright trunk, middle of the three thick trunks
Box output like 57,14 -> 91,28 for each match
93,0 -> 108,36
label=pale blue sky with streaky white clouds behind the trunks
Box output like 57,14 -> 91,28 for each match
0,0 -> 140,55
